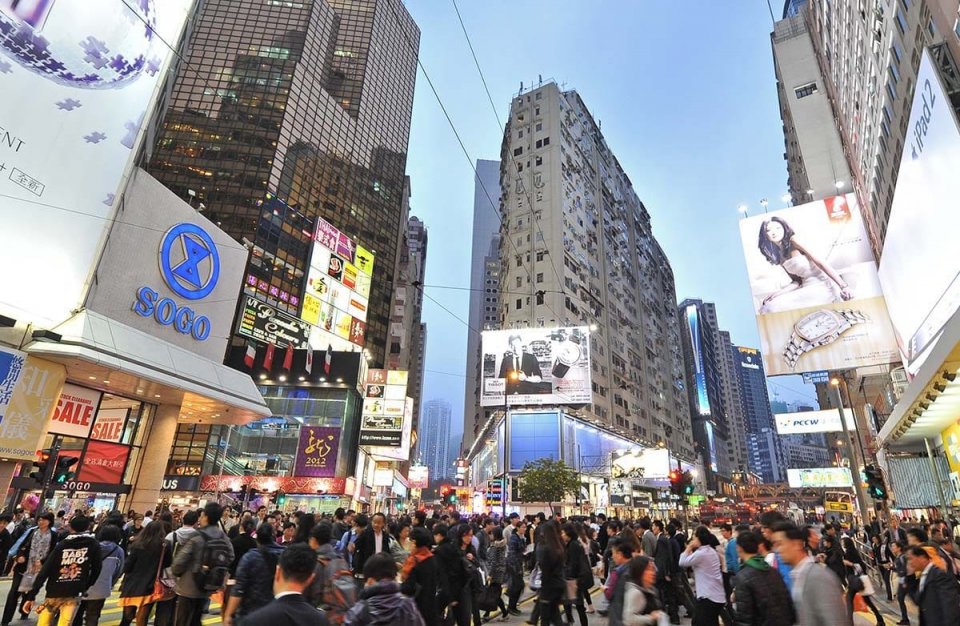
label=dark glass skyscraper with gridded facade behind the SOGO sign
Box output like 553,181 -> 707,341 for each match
149,0 -> 420,366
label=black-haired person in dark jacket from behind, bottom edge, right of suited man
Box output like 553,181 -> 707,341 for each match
344,553 -> 425,626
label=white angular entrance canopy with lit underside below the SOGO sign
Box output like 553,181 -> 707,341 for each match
24,311 -> 271,424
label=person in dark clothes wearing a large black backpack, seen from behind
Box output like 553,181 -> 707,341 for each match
170,502 -> 233,626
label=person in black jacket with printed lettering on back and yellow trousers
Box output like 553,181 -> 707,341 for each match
23,515 -> 102,626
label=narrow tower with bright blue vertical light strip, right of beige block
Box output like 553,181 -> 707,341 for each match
679,299 -> 739,491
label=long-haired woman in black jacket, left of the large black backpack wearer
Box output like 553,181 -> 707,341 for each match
120,523 -> 172,626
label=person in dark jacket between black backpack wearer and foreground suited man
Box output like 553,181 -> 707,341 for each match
223,524 -> 284,626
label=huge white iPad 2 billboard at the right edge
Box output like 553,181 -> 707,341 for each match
880,49 -> 960,374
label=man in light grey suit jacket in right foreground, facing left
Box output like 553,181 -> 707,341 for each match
773,522 -> 852,626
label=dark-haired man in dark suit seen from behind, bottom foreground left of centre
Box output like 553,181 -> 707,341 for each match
243,543 -> 329,626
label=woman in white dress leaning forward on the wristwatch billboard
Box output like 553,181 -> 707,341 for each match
757,217 -> 853,312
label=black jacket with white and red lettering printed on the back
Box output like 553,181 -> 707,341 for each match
25,533 -> 102,600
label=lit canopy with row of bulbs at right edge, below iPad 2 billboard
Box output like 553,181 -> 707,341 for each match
878,310 -> 960,449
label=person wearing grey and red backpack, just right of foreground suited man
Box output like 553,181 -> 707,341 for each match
304,522 -> 357,624
